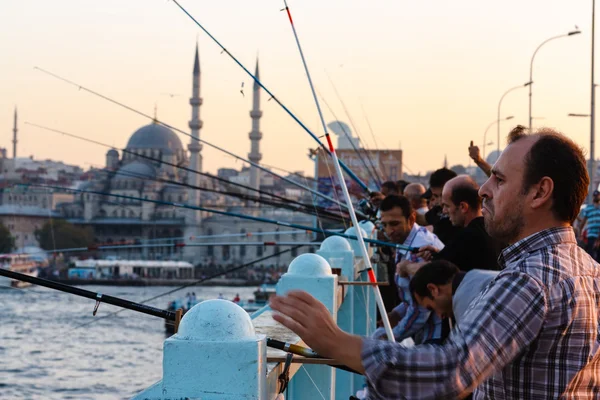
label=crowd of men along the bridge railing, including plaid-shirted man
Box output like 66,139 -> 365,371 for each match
271,126 -> 600,399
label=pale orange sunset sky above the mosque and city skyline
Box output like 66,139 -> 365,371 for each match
0,0 -> 592,174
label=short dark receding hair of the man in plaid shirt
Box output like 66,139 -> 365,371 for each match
508,125 -> 590,223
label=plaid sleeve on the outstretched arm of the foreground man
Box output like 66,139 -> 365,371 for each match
361,270 -> 546,399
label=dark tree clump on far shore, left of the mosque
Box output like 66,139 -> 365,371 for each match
35,219 -> 94,250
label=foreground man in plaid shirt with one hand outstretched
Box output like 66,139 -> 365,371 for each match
271,127 -> 600,400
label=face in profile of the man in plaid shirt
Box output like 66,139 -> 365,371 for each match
479,138 -> 532,244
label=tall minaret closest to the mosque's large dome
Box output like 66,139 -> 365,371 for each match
188,43 -> 202,212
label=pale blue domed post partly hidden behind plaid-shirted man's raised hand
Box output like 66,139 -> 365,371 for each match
277,253 -> 338,400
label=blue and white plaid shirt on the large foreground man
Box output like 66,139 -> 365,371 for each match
362,228 -> 600,400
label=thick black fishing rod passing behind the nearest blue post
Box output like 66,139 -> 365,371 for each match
0,268 -> 358,373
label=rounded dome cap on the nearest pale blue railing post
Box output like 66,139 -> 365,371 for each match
176,300 -> 256,342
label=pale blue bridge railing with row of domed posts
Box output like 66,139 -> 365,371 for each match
133,223 -> 376,400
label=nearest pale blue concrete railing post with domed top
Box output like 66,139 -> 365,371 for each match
133,300 -> 267,400
